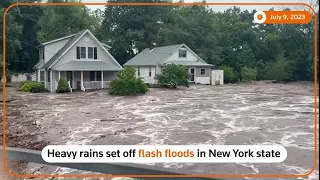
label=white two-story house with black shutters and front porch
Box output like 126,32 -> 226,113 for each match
34,30 -> 123,92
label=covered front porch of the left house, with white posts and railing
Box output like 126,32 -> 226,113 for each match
46,60 -> 122,92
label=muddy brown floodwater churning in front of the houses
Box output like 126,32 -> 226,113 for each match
3,82 -> 319,180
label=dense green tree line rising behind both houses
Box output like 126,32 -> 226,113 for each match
0,0 -> 319,82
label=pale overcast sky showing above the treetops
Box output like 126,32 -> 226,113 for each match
82,0 -> 310,11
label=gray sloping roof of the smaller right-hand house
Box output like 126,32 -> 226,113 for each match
124,44 -> 184,66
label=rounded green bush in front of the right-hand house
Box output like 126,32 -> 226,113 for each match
157,64 -> 190,88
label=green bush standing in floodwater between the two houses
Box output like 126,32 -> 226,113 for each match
109,67 -> 149,96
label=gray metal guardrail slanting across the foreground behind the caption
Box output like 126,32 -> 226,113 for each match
0,146 -> 222,180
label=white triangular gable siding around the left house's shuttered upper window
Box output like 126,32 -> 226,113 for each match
53,33 -> 116,69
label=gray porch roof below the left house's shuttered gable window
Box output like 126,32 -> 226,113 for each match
53,60 -> 122,71
